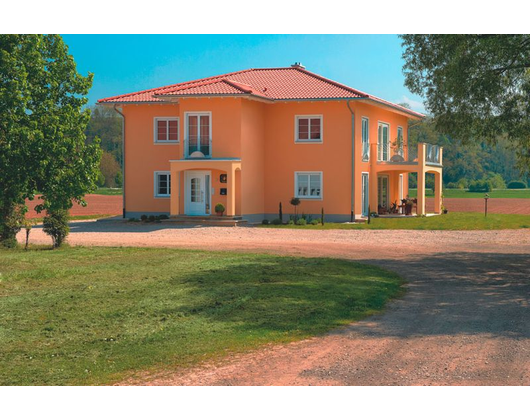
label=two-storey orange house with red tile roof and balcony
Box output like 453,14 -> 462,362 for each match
99,64 -> 442,222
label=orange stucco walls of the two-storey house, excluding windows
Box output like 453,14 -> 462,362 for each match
118,98 -> 408,217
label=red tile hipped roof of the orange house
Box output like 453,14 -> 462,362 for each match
98,66 -> 423,117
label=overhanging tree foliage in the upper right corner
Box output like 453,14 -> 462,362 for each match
401,34 -> 530,170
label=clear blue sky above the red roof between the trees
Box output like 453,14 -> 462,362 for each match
63,34 -> 424,112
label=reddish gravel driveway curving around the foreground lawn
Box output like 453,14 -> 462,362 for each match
19,223 -> 530,385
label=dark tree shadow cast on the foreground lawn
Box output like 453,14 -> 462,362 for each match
142,256 -> 402,338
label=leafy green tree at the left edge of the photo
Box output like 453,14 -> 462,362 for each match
0,34 -> 101,246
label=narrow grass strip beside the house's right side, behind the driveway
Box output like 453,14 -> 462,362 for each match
260,213 -> 530,230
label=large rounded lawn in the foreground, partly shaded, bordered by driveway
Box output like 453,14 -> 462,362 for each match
0,247 -> 402,385
